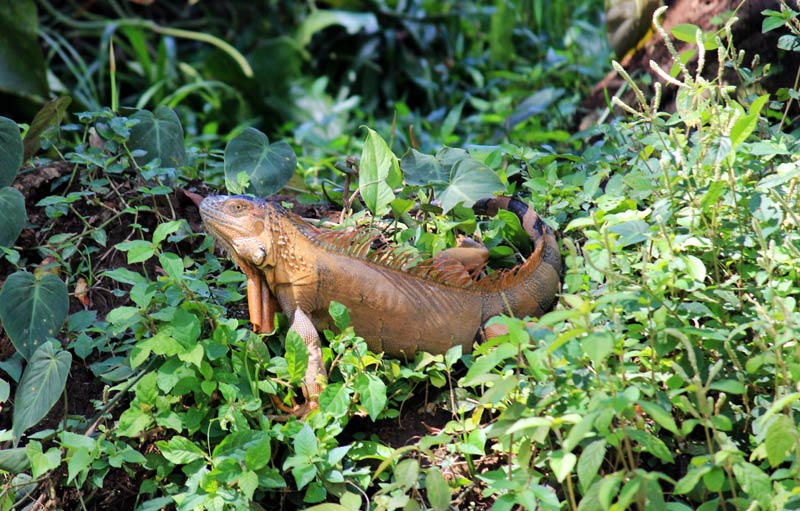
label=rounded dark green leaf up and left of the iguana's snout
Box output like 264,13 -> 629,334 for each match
128,106 -> 186,167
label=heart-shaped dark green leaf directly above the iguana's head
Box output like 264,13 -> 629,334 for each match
225,128 -> 297,197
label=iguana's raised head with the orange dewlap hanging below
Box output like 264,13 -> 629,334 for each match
200,195 -> 277,332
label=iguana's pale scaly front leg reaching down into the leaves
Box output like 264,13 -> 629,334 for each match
275,307 -> 328,418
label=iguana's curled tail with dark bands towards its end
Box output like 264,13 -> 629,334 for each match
472,197 -> 562,322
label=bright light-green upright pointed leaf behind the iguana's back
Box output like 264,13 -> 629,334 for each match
358,128 -> 400,216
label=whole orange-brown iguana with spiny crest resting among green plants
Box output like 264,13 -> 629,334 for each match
200,195 -> 561,416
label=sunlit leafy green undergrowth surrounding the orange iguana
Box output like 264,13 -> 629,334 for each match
0,3 -> 800,511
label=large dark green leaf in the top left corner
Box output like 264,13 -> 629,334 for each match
0,0 -> 48,98
